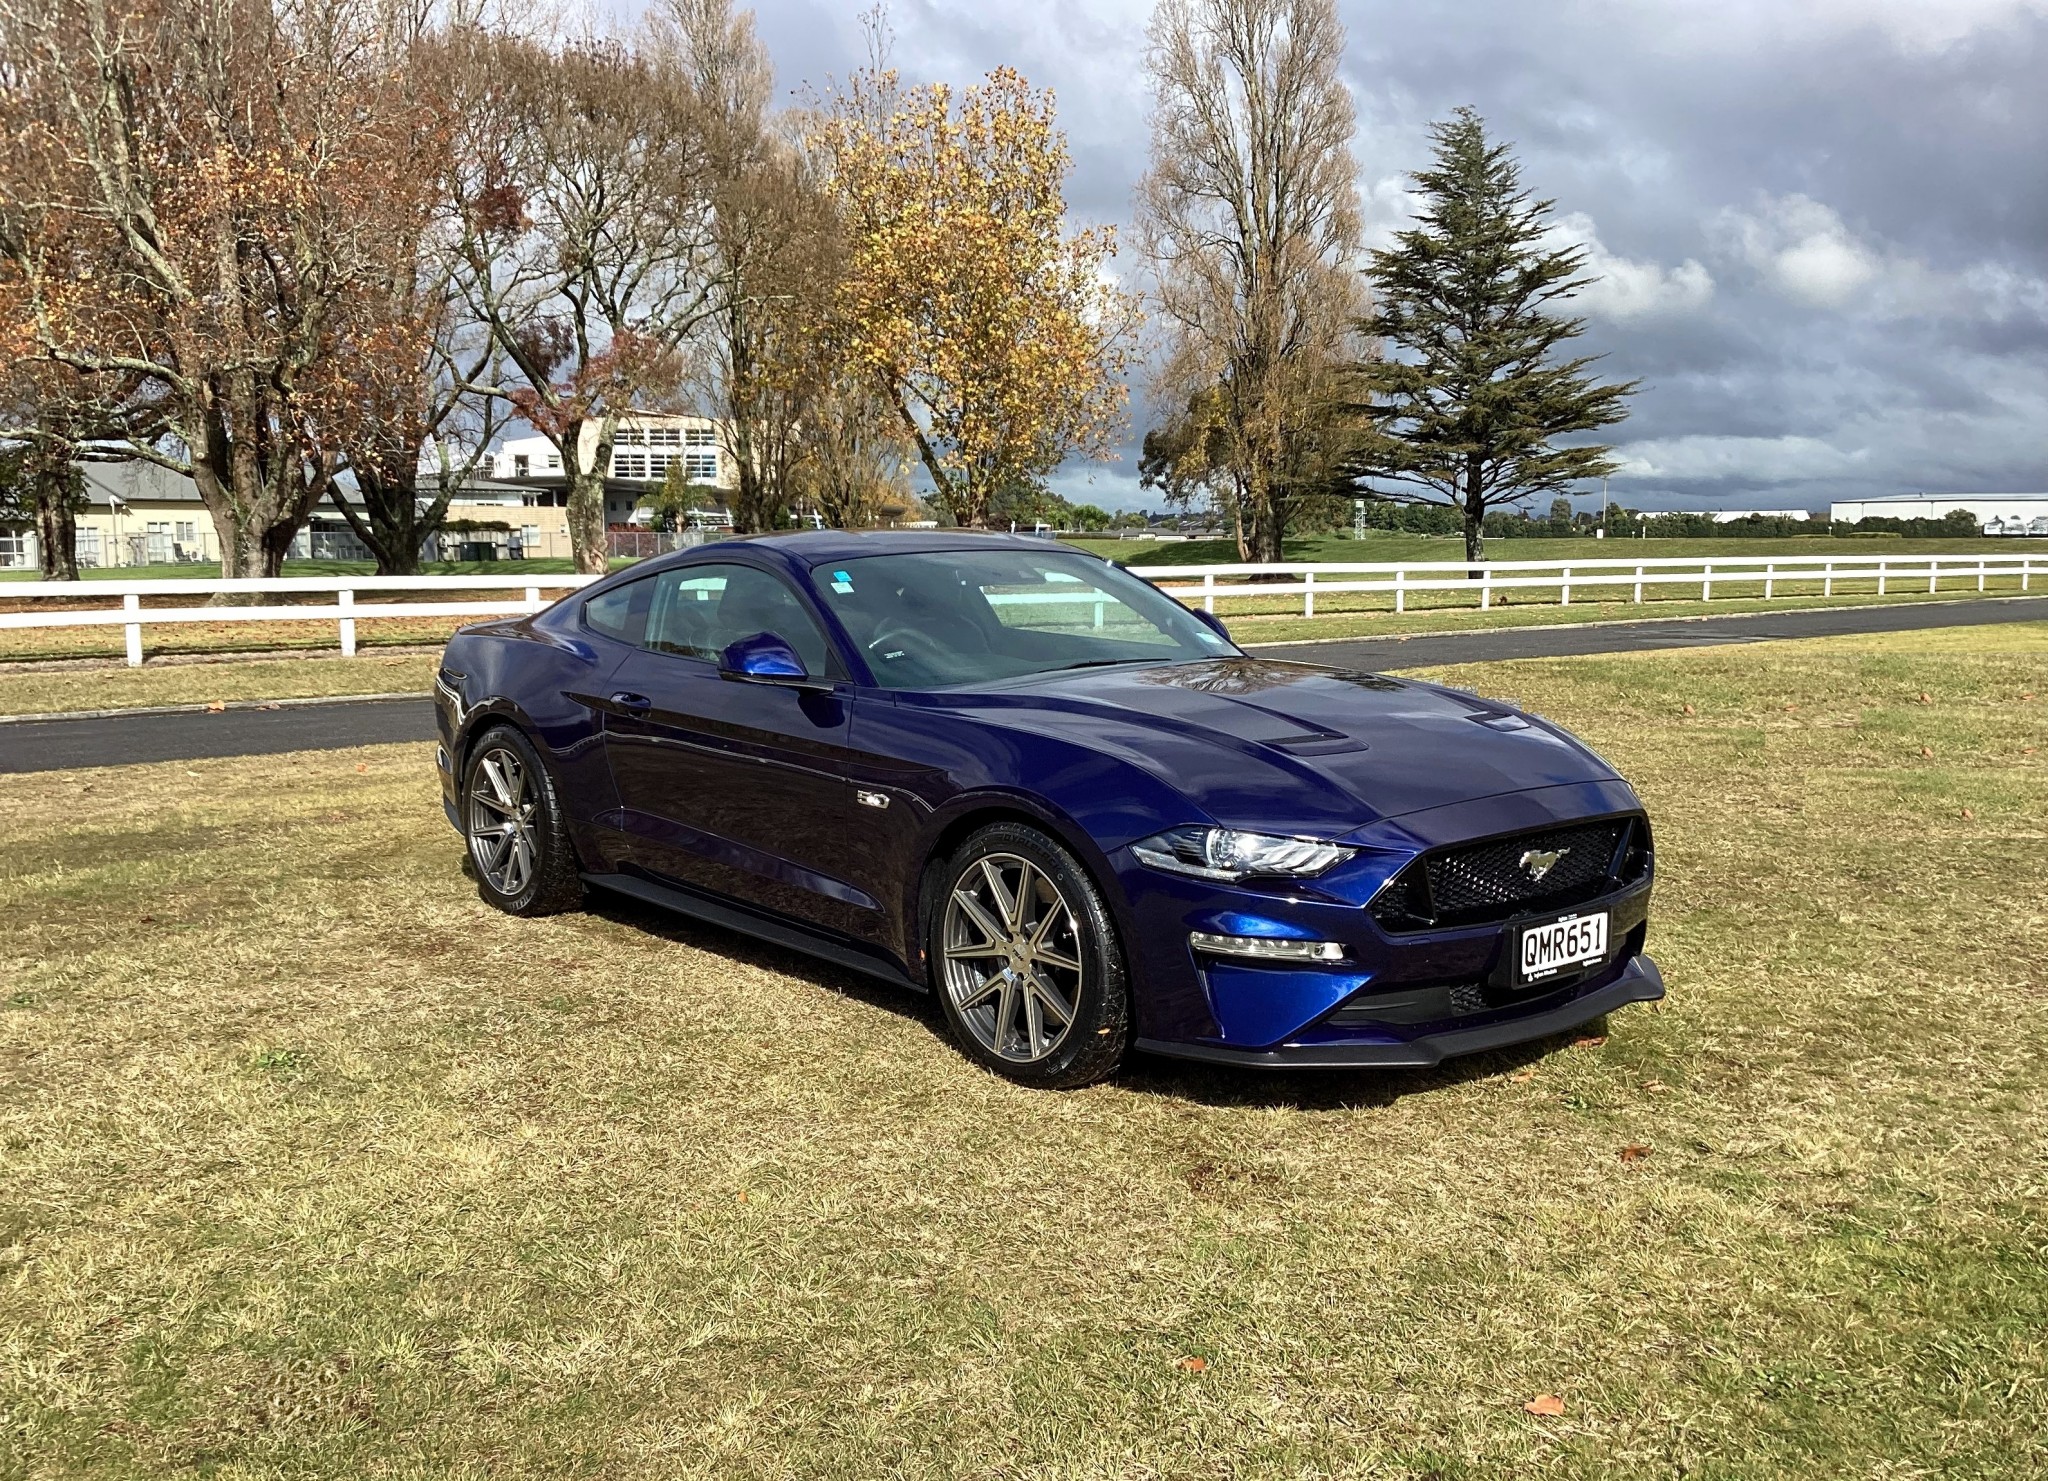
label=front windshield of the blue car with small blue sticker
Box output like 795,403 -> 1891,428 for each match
811,549 -> 1237,688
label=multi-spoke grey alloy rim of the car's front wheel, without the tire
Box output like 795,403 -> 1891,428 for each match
942,854 -> 1083,1063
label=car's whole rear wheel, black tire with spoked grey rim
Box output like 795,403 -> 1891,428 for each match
461,725 -> 584,916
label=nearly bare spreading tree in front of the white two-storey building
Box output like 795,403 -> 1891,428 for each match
451,29 -> 715,572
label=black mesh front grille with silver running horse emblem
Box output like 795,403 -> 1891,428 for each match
1372,817 -> 1649,930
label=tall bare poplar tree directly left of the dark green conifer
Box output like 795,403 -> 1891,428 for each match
1137,0 -> 1364,561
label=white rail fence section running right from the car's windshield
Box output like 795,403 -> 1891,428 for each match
1130,553 -> 2048,617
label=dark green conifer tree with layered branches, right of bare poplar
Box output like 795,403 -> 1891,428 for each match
1350,109 -> 1636,561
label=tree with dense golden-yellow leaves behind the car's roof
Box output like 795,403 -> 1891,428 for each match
809,66 -> 1135,528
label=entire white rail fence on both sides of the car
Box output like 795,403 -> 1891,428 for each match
0,553 -> 2048,664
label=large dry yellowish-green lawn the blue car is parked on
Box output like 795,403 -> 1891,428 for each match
0,625 -> 2048,1481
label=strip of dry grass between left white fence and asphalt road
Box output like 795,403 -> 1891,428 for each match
0,649 -> 440,715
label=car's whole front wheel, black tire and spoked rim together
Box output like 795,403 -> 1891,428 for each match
926,823 -> 1130,1090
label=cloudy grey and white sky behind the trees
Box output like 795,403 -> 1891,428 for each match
729,0 -> 2048,508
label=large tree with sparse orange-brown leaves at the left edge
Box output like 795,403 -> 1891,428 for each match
0,0 -> 438,576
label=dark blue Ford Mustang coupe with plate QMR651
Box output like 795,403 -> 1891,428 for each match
436,533 -> 1663,1086
